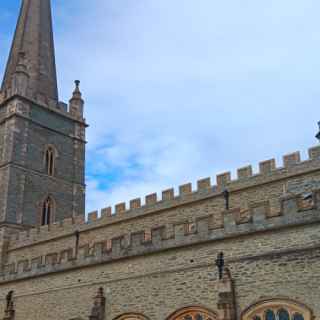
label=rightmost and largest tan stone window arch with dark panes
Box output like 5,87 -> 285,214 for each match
241,299 -> 313,320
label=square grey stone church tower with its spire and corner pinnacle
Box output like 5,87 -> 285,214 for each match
0,0 -> 86,227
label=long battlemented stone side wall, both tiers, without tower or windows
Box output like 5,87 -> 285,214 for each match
0,148 -> 320,320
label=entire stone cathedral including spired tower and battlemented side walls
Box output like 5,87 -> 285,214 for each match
0,0 -> 320,320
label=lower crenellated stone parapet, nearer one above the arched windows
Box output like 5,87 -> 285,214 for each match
0,190 -> 320,282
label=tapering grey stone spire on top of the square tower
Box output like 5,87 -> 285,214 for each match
1,0 -> 58,102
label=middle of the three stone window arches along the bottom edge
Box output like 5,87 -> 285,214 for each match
167,306 -> 218,320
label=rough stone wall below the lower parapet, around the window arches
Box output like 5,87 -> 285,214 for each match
0,211 -> 320,320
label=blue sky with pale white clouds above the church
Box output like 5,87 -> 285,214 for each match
0,0 -> 320,212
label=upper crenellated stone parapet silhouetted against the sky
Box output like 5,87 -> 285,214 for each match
88,146 -> 320,223
